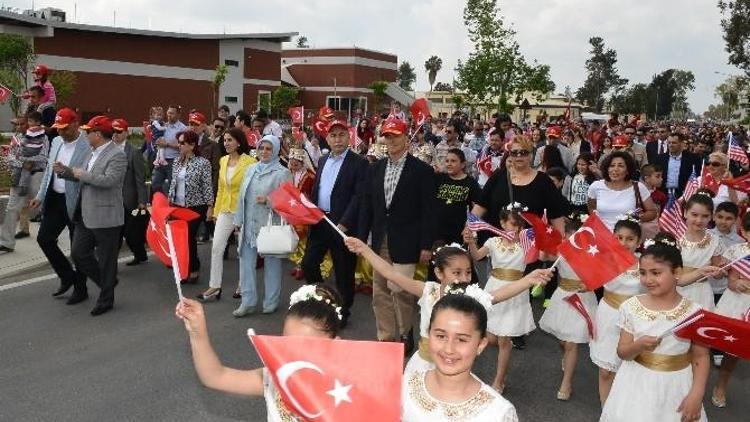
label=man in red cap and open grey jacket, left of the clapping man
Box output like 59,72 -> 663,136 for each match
29,108 -> 91,305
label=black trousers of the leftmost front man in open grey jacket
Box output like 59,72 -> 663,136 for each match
36,190 -> 85,286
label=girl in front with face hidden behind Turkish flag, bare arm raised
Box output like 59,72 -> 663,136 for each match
175,284 -> 341,422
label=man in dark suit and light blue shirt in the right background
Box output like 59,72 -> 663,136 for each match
657,132 -> 701,198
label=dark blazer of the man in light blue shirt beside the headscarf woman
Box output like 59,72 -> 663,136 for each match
310,150 -> 367,235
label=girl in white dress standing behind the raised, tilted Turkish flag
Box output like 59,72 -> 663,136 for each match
539,213 -> 596,401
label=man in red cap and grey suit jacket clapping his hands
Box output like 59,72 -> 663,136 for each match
55,116 -> 128,316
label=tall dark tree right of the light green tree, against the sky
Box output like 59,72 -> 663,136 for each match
576,37 -> 628,113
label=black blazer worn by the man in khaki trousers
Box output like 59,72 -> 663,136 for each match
358,154 -> 437,264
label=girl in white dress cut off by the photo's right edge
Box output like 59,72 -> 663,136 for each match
711,214 -> 750,407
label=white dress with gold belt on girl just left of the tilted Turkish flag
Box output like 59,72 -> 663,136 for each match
484,237 -> 536,337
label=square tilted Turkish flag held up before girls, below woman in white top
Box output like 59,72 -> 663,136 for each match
558,214 -> 636,290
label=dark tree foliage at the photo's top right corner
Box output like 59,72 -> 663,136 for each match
719,0 -> 750,76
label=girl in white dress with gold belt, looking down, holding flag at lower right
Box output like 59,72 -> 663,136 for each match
600,234 -> 709,422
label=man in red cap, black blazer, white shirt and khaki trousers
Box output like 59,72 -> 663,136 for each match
358,118 -> 437,353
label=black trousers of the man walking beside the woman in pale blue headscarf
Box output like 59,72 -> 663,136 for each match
302,221 -> 357,317
